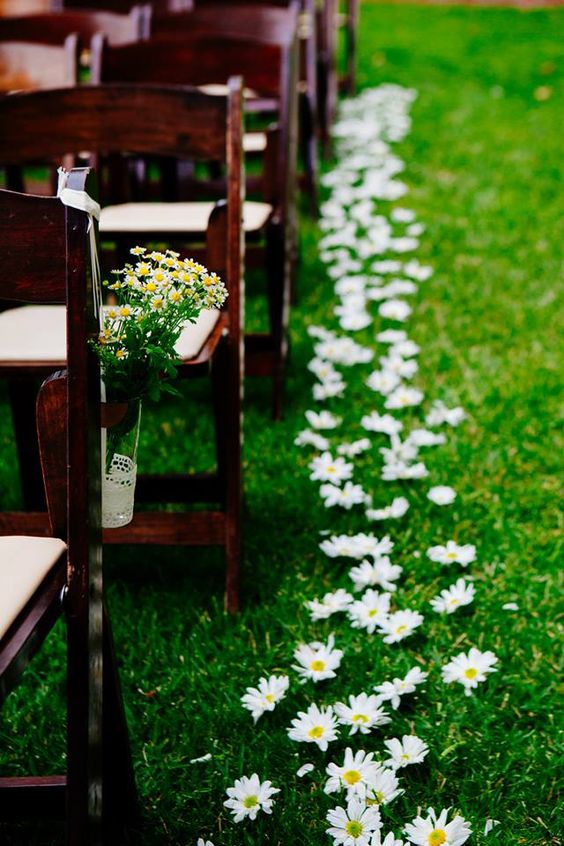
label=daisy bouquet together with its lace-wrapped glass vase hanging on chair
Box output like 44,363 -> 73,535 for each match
93,247 -> 227,528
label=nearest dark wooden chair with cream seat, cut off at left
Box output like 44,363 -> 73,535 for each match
0,170 -> 136,846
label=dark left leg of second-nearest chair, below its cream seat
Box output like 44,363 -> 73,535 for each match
8,378 -> 47,511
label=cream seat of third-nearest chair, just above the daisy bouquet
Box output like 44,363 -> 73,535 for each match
100,200 -> 272,234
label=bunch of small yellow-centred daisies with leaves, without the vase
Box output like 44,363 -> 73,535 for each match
93,247 -> 227,402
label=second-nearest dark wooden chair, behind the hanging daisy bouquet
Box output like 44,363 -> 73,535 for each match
0,79 -> 244,611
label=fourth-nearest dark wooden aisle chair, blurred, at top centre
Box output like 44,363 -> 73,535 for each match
160,0 -> 318,216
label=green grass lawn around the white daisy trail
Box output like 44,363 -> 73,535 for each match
0,4 -> 564,846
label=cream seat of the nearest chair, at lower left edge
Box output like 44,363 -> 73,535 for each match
0,535 -> 67,639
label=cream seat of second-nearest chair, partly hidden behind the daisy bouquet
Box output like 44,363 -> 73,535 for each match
0,305 -> 220,367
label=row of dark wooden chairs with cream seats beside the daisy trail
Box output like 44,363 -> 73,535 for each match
0,3 -> 360,846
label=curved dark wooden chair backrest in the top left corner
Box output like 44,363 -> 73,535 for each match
0,5 -> 151,47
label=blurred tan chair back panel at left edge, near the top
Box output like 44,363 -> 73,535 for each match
0,34 -> 78,93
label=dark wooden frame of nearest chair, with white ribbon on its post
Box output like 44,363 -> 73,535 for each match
0,171 -> 123,844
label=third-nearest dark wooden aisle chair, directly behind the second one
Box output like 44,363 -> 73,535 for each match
92,32 -> 297,419
